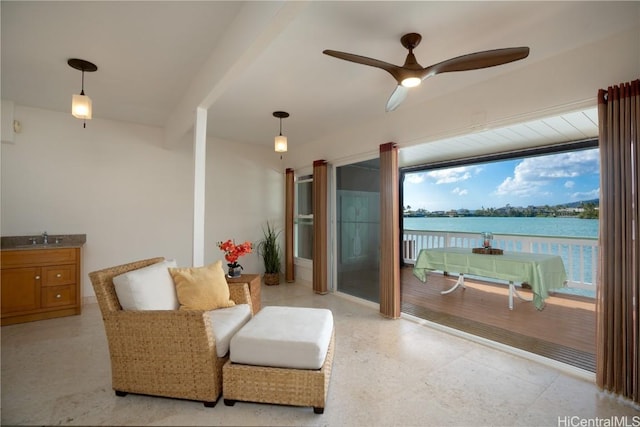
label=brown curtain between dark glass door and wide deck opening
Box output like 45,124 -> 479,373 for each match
380,142 -> 400,319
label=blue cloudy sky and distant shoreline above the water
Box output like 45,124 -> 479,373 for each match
403,141 -> 600,221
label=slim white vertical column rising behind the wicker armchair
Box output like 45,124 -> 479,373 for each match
192,107 -> 207,267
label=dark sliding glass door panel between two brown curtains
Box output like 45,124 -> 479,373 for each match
335,159 -> 380,303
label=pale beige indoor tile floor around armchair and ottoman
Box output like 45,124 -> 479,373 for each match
1,283 -> 640,427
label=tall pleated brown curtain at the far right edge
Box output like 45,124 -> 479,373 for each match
596,80 -> 640,403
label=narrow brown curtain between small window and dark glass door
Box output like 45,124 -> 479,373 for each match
313,160 -> 328,294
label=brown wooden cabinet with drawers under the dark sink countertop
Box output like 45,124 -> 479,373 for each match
0,247 -> 82,326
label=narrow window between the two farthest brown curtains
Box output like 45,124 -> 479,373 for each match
294,175 -> 313,260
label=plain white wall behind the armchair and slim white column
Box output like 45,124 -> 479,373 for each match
0,105 -> 284,297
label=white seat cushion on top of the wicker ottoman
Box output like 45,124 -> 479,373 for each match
229,306 -> 333,369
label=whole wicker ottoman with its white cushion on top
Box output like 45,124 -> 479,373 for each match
222,307 -> 335,414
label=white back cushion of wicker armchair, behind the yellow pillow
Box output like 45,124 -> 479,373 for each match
113,259 -> 180,310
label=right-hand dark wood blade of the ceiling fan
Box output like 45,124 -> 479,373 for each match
422,47 -> 529,79
